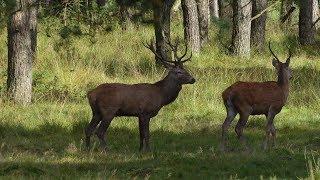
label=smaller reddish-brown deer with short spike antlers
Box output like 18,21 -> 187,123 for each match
222,42 -> 292,150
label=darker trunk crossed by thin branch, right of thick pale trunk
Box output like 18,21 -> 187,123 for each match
251,0 -> 268,51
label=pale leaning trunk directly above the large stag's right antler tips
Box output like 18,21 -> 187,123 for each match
181,0 -> 201,53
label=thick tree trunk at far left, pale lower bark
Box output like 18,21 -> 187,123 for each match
7,0 -> 38,105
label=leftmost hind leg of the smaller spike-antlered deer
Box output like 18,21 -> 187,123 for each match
221,100 -> 237,151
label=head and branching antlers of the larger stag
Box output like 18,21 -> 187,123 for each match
144,39 -> 196,84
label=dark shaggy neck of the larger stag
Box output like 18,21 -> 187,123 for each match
155,73 -> 182,105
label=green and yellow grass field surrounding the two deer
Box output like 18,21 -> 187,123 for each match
0,16 -> 320,179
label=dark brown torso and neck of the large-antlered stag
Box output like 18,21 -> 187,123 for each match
88,76 -> 182,117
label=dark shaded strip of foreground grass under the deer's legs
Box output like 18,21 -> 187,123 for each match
0,116 -> 320,179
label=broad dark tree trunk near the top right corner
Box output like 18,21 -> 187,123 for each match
299,0 -> 315,45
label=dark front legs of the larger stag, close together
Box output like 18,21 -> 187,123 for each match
139,117 -> 150,152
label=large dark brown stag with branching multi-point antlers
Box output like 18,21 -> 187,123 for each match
85,40 -> 196,151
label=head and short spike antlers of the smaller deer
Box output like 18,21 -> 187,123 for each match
269,42 -> 292,79
